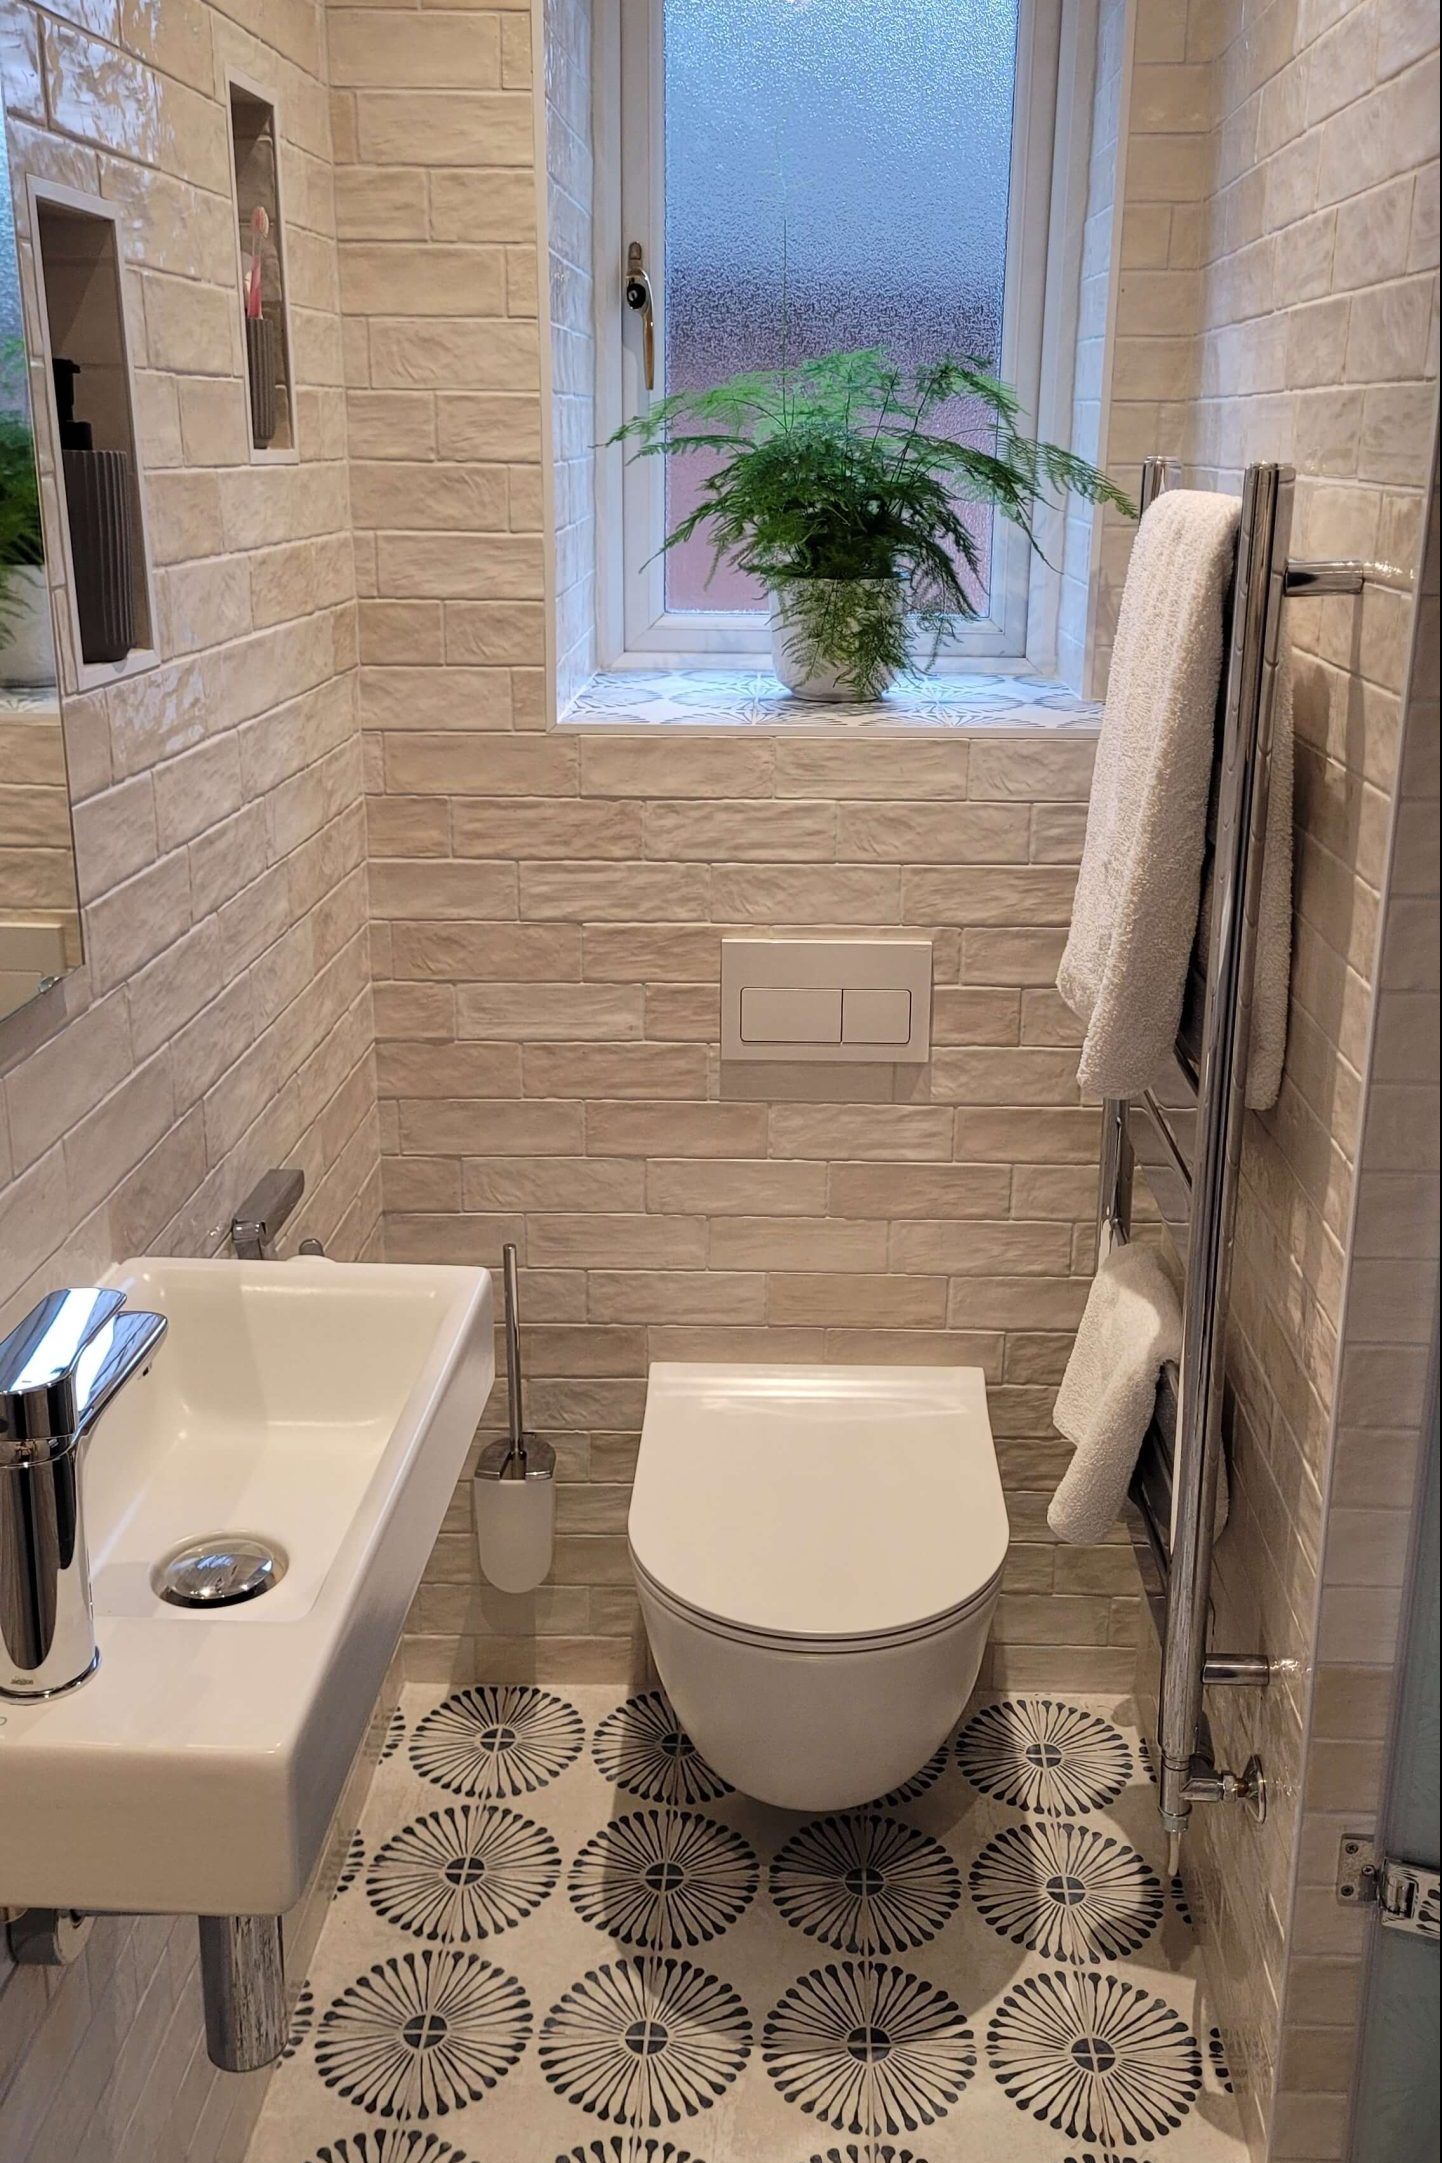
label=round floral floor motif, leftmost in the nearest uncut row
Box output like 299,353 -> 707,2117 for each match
316,1949 -> 532,2120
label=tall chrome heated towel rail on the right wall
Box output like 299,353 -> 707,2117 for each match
1098,459 -> 1368,1834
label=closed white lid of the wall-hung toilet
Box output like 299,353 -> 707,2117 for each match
629,1363 -> 1010,1637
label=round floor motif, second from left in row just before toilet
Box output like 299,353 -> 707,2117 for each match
571,1810 -> 759,1953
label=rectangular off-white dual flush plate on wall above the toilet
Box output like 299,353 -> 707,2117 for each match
722,939 -> 932,1066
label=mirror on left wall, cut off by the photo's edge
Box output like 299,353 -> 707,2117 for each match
0,84 -> 80,1014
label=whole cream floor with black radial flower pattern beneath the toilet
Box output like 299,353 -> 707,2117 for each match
239,1687 -> 1243,2163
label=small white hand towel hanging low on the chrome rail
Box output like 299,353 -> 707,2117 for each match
1046,1242 -> 1183,1547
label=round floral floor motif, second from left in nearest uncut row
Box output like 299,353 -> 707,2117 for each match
540,1955 -> 752,2133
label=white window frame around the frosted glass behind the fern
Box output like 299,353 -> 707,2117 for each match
595,0 -> 1062,671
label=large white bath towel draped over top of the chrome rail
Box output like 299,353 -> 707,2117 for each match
1057,489 -> 1293,1110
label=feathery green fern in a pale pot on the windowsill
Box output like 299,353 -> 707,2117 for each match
612,348 -> 1135,699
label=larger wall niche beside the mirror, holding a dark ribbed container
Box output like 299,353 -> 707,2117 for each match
30,177 -> 156,690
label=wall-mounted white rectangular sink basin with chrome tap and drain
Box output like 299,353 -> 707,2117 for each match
0,1259 -> 495,1914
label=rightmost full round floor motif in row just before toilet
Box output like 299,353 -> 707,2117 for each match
971,1819 -> 1163,1966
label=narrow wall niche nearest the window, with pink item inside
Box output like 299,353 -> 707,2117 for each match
227,76 -> 296,463
